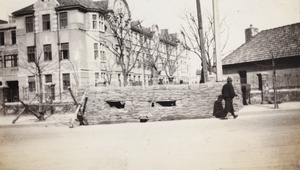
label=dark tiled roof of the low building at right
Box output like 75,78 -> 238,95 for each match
222,23 -> 300,65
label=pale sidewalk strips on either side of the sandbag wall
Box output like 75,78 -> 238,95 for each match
0,102 -> 300,128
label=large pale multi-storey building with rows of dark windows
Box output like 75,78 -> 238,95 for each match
0,0 -> 189,101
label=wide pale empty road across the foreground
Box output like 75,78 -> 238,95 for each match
0,110 -> 300,170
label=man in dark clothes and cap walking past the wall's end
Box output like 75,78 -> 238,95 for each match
221,77 -> 238,119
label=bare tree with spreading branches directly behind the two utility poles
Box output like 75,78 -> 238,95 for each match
181,11 -> 229,82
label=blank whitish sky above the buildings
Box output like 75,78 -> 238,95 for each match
0,0 -> 300,71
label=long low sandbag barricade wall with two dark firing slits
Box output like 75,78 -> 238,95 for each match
86,83 -> 242,124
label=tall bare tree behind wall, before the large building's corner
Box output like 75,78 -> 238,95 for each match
104,12 -> 147,86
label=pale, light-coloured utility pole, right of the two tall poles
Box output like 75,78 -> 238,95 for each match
213,0 -> 223,82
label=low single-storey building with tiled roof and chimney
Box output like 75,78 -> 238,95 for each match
222,23 -> 300,103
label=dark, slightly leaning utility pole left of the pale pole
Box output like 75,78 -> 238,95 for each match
196,0 -> 207,83
